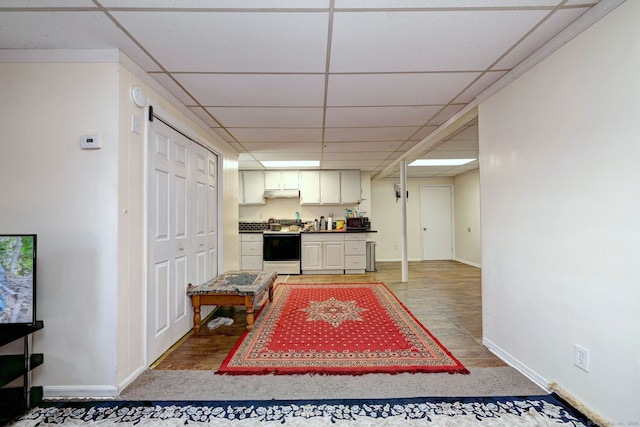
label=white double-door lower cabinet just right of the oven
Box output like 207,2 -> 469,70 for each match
300,233 -> 345,274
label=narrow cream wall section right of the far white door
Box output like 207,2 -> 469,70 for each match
453,170 -> 482,267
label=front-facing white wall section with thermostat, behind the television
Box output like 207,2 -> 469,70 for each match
0,63 -> 118,392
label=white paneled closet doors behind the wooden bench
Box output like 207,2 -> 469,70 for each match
147,120 -> 218,362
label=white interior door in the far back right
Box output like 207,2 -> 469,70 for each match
420,185 -> 453,260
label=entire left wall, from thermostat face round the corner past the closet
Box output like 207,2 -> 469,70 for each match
0,55 -> 238,396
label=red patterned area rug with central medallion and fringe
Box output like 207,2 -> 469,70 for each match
216,283 -> 469,375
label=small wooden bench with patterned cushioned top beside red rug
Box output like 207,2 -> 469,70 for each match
187,271 -> 278,332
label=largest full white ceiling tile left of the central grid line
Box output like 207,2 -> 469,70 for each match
112,11 -> 328,72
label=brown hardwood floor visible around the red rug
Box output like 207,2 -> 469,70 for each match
152,261 -> 507,370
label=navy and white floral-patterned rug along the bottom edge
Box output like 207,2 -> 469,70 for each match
9,394 -> 593,427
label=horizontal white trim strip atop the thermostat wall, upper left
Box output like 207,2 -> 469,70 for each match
0,49 -> 120,63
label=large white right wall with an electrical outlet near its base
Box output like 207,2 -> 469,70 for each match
479,1 -> 640,425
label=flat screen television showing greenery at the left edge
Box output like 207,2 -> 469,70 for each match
0,234 -> 37,329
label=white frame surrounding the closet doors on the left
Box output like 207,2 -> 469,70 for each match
142,105 -> 224,367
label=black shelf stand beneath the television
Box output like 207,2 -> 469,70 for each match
0,320 -> 44,425
